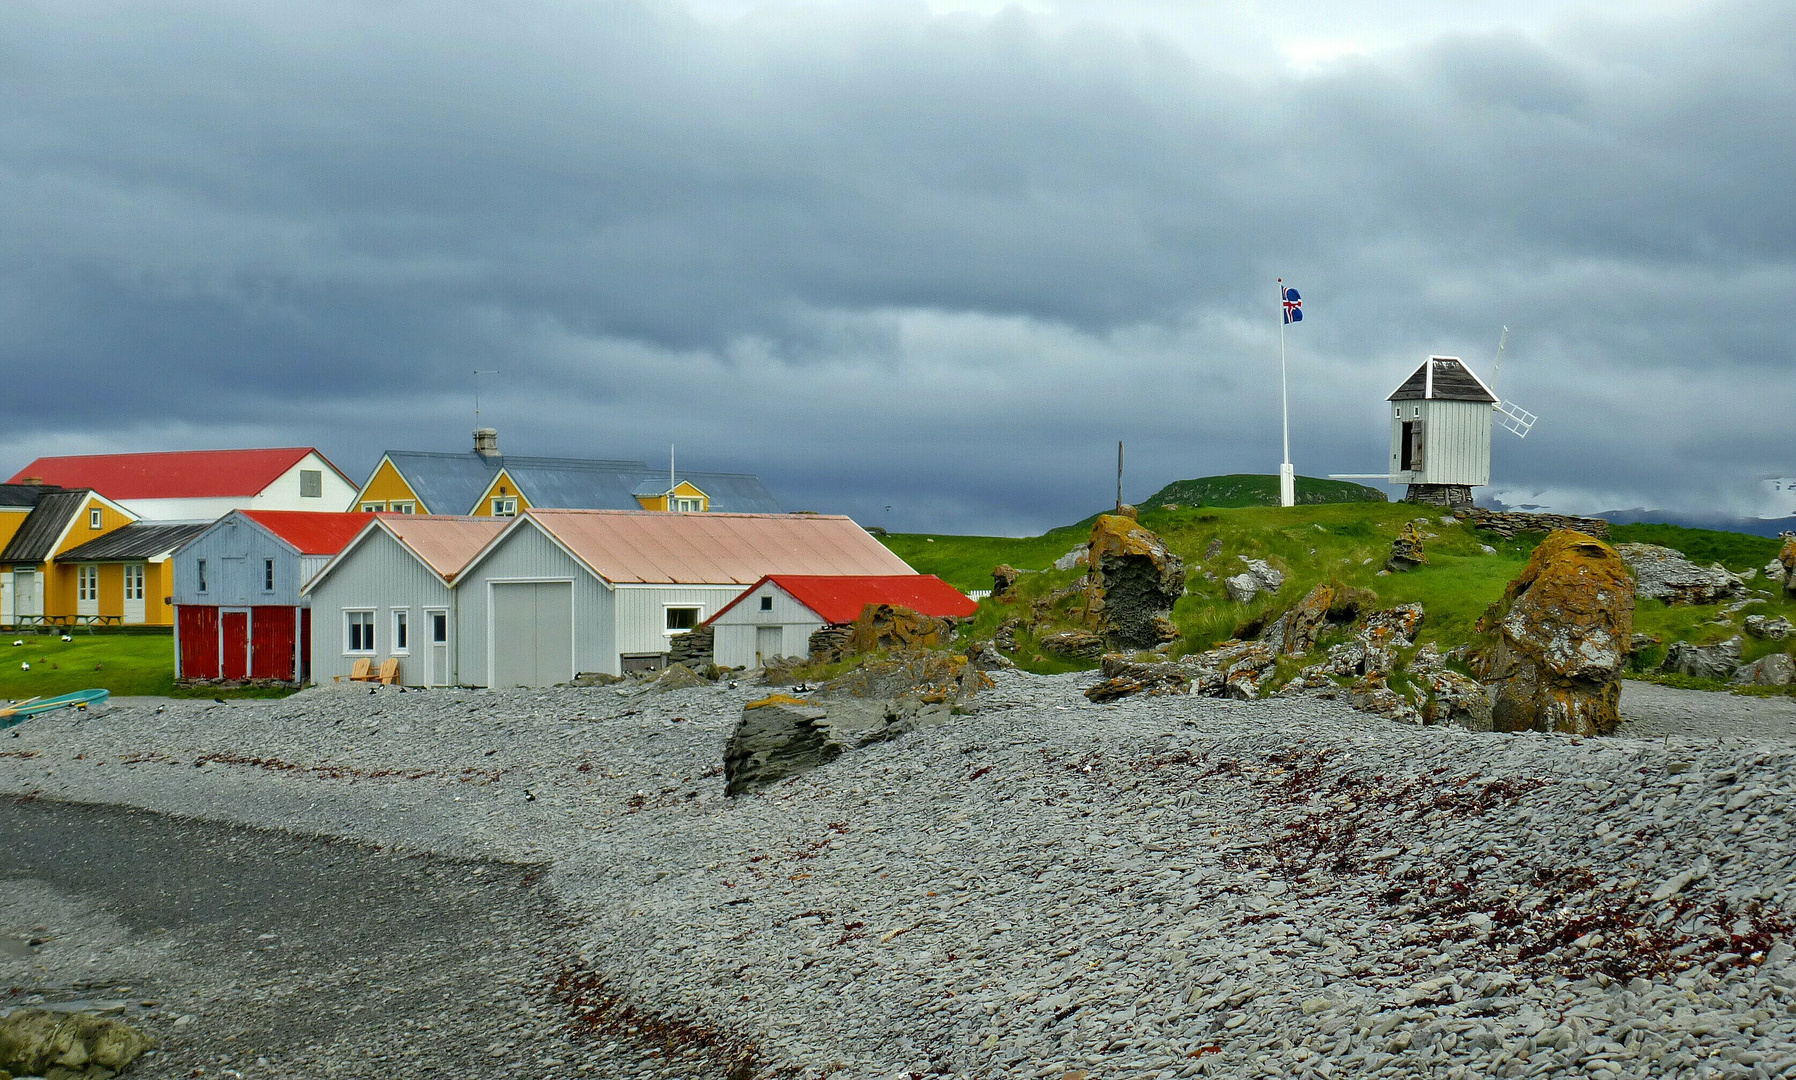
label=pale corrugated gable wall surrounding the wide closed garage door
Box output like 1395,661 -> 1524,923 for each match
453,525 -> 623,686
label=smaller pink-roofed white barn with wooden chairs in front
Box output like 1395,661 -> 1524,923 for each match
304,514 -> 508,686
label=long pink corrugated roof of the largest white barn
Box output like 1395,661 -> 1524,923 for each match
528,510 -> 916,586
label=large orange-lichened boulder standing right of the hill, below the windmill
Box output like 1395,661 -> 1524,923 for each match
1478,532 -> 1634,735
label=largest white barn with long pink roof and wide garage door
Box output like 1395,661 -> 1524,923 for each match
454,509 -> 916,686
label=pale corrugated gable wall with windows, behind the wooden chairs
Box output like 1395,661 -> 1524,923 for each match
311,530 -> 452,685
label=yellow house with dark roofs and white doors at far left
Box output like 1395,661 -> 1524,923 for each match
0,485 -> 205,625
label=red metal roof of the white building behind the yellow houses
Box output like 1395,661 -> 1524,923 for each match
11,446 -> 330,500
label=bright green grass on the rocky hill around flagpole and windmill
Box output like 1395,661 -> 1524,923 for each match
885,501 -> 1796,670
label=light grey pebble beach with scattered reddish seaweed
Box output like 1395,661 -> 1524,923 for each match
0,674 -> 1796,1080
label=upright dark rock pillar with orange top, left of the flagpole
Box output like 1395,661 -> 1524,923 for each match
1085,514 -> 1185,649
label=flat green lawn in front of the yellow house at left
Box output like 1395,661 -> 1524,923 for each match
0,631 -> 287,701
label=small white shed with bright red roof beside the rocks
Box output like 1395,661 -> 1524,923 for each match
708,573 -> 979,667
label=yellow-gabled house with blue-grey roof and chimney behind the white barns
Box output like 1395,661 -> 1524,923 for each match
348,428 -> 781,518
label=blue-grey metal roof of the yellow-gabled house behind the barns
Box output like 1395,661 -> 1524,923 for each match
386,449 -> 779,514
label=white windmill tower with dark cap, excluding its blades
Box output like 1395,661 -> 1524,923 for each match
1388,356 -> 1496,507
